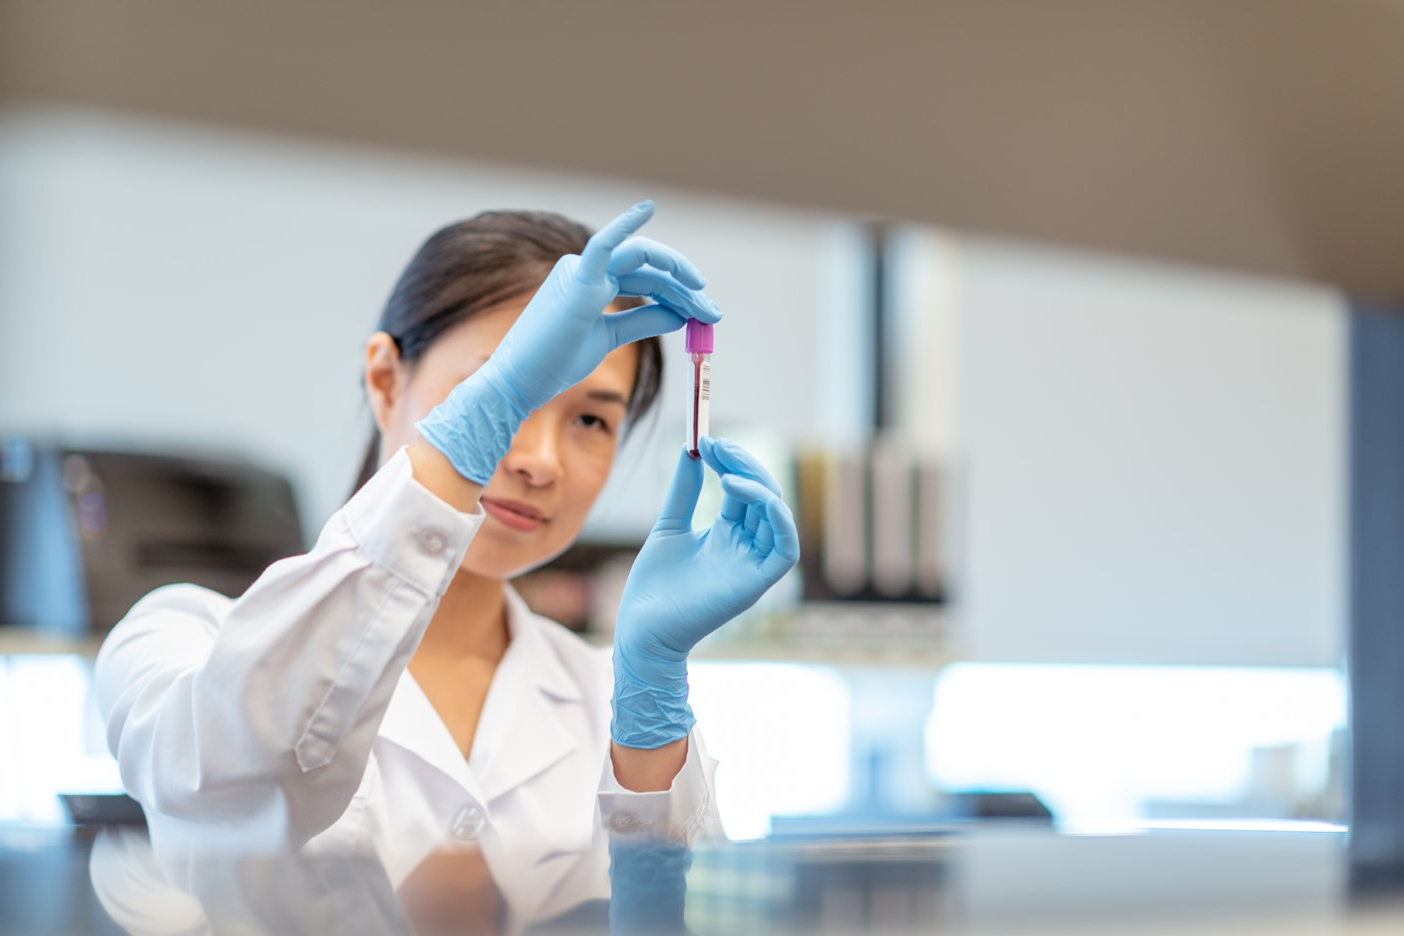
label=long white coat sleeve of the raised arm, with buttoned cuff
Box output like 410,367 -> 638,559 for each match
95,449 -> 483,848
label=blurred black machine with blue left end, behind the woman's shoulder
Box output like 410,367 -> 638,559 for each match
0,438 -> 303,636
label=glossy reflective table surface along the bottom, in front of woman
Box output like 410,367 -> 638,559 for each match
0,824 -> 1404,936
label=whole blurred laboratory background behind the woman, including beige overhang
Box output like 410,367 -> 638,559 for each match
8,1 -> 1404,931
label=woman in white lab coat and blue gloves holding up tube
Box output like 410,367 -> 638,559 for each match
97,202 -> 797,909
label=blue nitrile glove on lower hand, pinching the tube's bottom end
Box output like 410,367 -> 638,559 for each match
609,438 -> 799,748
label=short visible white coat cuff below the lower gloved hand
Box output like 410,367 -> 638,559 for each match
598,728 -> 720,843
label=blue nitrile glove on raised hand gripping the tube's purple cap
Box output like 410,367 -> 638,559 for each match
414,202 -> 722,486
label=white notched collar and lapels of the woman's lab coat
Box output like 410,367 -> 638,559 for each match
380,588 -> 584,803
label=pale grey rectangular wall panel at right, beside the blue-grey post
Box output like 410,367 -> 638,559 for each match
955,240 -> 1346,667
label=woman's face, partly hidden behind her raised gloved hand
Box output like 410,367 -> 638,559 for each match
366,299 -> 639,580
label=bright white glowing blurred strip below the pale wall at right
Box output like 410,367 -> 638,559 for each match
925,664 -> 1346,832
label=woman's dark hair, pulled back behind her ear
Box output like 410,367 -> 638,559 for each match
354,212 -> 663,490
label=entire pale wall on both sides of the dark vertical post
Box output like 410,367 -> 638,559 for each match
0,111 -> 1345,665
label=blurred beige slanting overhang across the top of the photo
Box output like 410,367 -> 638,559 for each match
0,0 -> 1404,297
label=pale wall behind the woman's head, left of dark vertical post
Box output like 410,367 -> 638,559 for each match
0,111 -> 859,536
